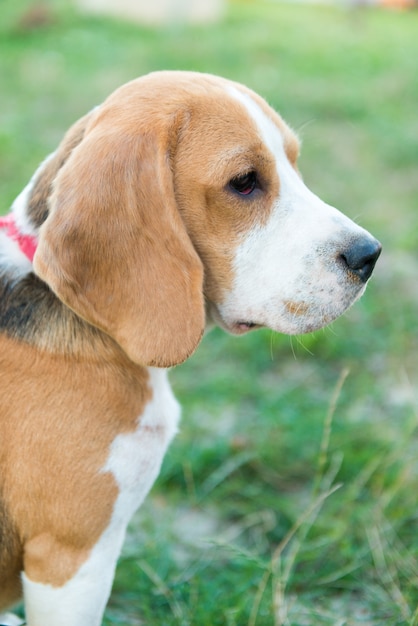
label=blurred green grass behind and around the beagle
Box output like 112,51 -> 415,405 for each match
0,0 -> 418,626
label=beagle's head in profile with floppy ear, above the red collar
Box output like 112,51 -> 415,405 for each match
29,72 -> 380,367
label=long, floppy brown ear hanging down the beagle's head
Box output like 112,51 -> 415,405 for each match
34,125 -> 204,367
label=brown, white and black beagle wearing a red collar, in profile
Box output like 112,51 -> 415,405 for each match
0,72 -> 380,626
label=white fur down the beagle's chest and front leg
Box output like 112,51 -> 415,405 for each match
22,368 -> 180,626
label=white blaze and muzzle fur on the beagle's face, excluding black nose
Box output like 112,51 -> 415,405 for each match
214,88 -> 371,334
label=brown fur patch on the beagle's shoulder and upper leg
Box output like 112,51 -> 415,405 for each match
0,337 -> 151,585
